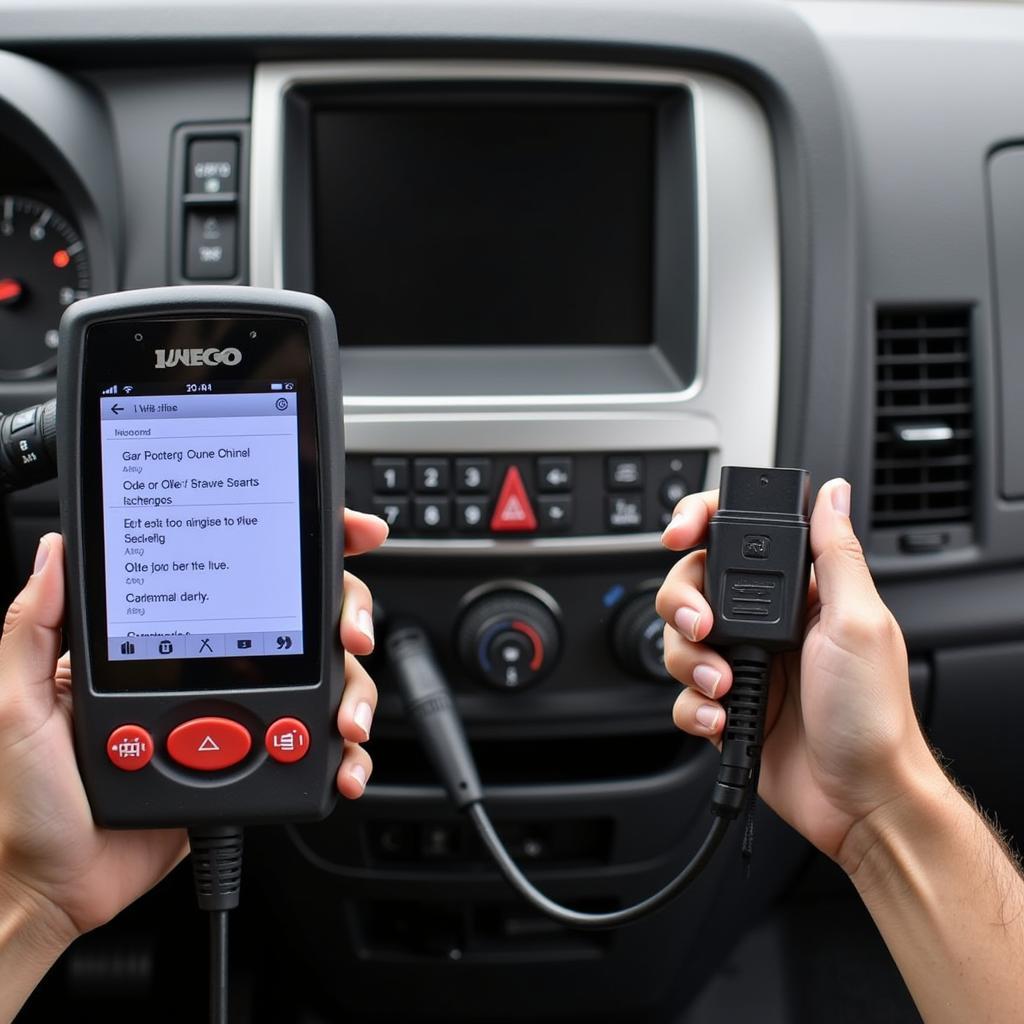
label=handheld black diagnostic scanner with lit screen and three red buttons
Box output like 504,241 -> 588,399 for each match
57,286 -> 344,827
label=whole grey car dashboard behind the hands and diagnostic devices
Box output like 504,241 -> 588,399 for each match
0,0 -> 1024,1024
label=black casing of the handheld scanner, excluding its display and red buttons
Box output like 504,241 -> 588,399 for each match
57,286 -> 344,827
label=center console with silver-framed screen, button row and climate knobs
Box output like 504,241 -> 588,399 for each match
250,60 -> 780,1017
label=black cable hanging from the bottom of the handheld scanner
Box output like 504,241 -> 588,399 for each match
188,825 -> 243,1024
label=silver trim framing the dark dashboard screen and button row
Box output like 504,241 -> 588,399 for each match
250,59 -> 781,557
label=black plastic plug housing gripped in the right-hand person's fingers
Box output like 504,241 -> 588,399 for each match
705,466 -> 811,652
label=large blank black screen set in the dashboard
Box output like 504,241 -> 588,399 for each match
310,101 -> 656,347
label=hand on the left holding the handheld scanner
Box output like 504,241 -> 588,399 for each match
0,510 -> 387,945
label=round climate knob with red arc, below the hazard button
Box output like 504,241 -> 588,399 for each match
458,591 -> 558,690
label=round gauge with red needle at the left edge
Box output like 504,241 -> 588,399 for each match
0,196 -> 90,380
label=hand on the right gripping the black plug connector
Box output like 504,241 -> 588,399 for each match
656,479 -> 939,863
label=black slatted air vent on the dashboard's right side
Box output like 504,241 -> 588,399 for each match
872,309 -> 974,528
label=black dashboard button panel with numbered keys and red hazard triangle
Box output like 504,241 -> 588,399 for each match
346,451 -> 708,540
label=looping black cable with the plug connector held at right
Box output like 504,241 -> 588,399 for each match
385,467 -> 810,930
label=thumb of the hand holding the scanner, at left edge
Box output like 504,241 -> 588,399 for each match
0,534 -> 65,707
